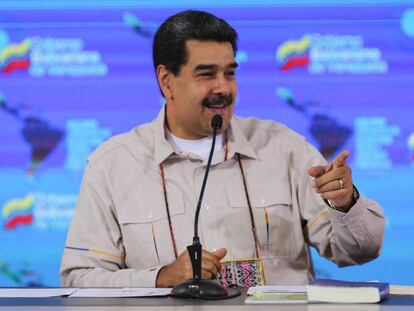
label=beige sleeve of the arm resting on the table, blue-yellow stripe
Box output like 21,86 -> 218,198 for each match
60,165 -> 161,287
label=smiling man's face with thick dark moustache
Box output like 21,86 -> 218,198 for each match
163,40 -> 237,139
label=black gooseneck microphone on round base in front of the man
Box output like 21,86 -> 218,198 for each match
170,114 -> 240,299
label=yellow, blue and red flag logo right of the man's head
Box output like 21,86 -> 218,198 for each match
276,36 -> 311,71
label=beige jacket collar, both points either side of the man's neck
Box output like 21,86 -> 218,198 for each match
154,106 -> 258,165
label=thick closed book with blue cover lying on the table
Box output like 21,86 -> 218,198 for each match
306,279 -> 390,303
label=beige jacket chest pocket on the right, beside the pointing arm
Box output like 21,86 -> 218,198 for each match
226,181 -> 297,257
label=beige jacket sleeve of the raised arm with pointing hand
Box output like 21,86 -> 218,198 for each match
298,145 -> 385,266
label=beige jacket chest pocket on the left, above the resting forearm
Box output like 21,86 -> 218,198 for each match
118,189 -> 185,269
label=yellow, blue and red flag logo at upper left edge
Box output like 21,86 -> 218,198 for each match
0,39 -> 30,73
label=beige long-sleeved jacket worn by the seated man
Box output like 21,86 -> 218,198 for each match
61,109 -> 384,287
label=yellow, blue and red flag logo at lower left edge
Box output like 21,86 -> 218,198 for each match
1,193 -> 34,230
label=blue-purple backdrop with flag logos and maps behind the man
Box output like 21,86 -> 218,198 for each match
0,1 -> 414,286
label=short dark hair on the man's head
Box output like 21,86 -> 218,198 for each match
152,10 -> 237,75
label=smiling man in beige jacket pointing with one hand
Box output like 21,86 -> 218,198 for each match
61,11 -> 384,287
